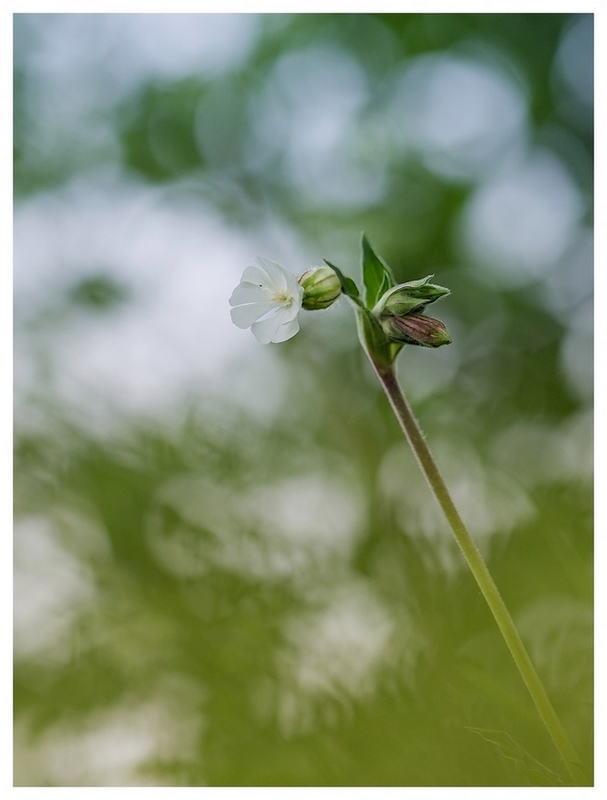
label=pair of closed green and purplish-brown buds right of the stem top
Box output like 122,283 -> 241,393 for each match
373,275 -> 451,347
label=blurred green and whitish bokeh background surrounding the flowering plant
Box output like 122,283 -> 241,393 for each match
14,14 -> 593,786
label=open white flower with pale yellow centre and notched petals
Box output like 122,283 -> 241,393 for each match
230,258 -> 303,344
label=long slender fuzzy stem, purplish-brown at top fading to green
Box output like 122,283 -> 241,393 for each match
365,360 -> 588,785
